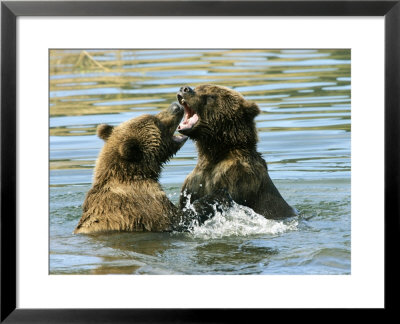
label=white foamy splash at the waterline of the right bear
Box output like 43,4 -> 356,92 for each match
189,203 -> 298,239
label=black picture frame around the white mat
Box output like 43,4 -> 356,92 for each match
0,0 -> 400,323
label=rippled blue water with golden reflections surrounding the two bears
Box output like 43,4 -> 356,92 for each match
49,49 -> 351,274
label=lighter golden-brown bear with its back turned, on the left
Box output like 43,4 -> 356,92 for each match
74,103 -> 233,233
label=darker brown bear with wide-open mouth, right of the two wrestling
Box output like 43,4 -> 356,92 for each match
177,84 -> 297,219
